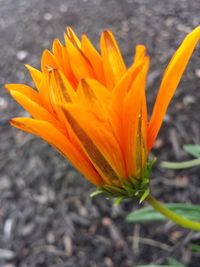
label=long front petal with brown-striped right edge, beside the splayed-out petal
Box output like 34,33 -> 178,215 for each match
122,57 -> 149,177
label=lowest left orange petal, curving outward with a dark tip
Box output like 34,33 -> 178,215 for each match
11,118 -> 102,186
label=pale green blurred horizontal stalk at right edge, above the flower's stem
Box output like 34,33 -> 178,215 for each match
160,158 -> 200,170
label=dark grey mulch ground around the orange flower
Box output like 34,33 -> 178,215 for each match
0,0 -> 200,267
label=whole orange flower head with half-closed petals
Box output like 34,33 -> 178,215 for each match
6,26 -> 200,199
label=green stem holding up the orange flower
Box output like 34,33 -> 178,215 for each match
146,195 -> 200,231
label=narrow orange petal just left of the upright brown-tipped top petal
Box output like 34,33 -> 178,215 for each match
81,34 -> 105,85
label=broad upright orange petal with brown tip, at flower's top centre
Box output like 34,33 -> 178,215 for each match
100,31 -> 126,90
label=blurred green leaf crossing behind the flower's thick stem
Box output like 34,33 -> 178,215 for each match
126,203 -> 200,223
